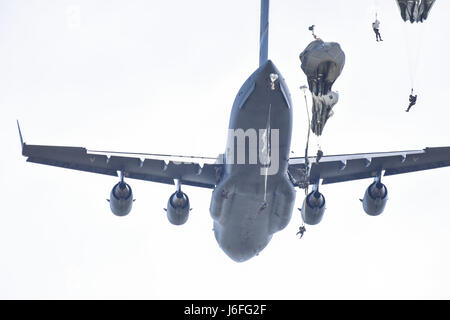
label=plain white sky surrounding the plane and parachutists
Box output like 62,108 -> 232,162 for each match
0,0 -> 450,299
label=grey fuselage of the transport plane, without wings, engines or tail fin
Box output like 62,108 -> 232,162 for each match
210,60 -> 295,262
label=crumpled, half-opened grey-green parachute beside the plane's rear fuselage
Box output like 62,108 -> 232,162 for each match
300,39 -> 345,136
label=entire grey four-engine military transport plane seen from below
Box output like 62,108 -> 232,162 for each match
19,0 -> 450,262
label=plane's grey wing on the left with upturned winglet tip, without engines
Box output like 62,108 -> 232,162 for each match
17,123 -> 223,188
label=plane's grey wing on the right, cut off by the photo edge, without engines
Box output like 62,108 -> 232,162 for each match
288,147 -> 450,185
